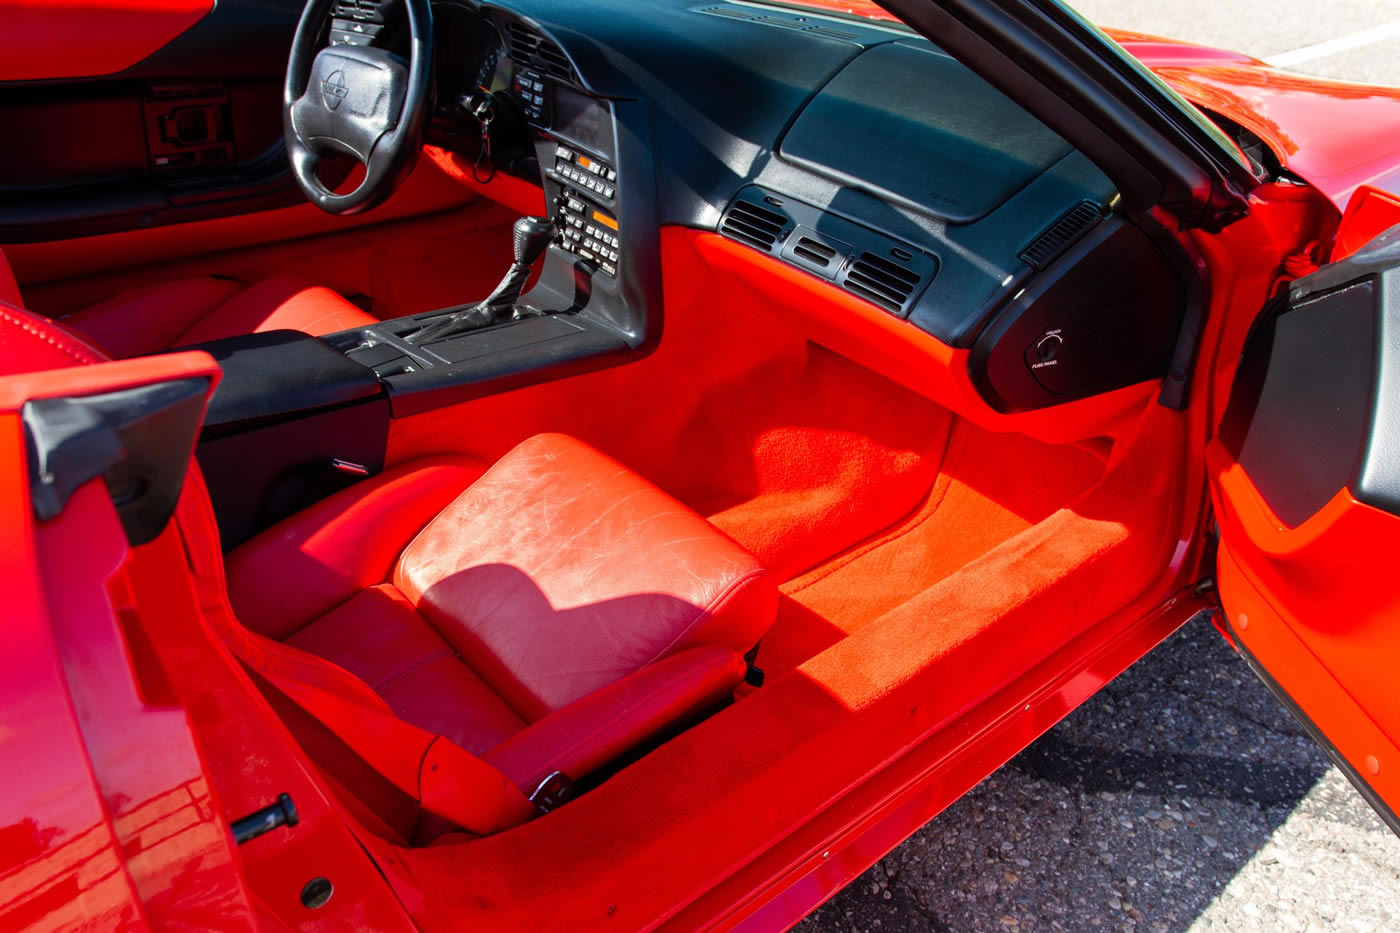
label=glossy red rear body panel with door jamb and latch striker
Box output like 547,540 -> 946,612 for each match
0,353 -> 420,930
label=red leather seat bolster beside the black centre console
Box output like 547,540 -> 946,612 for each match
225,457 -> 486,640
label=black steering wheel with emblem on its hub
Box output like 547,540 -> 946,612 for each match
281,0 -> 433,214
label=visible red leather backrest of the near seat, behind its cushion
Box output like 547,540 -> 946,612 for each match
0,303 -> 535,834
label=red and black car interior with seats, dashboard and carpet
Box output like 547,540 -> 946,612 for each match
0,0 -> 1288,927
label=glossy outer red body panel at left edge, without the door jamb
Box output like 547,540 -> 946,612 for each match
0,354 -> 255,930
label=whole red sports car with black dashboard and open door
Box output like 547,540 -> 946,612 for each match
0,0 -> 1400,930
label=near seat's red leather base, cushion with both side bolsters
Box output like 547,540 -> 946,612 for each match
227,434 -> 777,822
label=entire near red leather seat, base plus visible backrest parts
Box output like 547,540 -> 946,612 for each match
0,304 -> 777,841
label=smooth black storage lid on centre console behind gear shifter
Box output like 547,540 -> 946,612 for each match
179,331 -> 382,430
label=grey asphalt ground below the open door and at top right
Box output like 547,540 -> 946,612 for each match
798,0 -> 1400,933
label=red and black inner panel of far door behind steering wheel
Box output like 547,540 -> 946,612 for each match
0,0 -> 316,242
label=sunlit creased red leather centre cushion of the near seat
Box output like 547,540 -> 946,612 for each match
395,434 -> 777,720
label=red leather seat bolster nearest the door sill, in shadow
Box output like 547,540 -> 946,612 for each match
484,644 -> 745,794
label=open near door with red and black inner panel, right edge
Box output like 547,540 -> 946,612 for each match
1207,216 -> 1400,832
